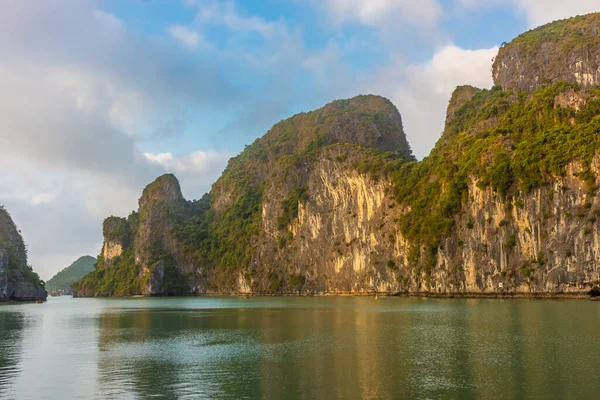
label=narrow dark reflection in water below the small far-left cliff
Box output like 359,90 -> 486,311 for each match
0,312 -> 25,398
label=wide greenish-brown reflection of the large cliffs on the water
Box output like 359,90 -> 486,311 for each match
94,298 -> 600,399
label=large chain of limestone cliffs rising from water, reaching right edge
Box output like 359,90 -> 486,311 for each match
75,15 -> 600,296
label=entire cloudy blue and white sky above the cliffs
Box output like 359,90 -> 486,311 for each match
0,0 -> 600,280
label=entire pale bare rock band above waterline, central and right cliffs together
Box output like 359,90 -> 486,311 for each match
239,148 -> 600,295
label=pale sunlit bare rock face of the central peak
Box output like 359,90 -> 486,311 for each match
244,145 -> 399,293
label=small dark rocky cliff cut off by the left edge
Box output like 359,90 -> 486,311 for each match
0,207 -> 47,302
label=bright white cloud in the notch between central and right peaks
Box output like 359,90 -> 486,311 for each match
364,45 -> 498,158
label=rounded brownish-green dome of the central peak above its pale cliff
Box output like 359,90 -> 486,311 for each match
211,95 -> 415,213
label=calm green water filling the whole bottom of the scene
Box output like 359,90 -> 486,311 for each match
0,297 -> 600,399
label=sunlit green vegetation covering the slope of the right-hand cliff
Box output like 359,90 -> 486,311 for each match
377,82 -> 600,268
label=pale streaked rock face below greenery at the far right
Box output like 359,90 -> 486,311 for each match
428,157 -> 600,294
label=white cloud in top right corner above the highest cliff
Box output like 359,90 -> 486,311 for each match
460,0 -> 600,28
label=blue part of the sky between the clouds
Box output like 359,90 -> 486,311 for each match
101,0 -> 528,157
